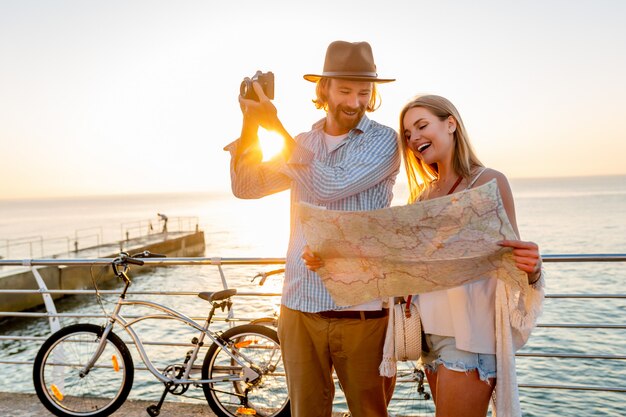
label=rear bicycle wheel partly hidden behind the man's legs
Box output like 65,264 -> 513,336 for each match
202,324 -> 291,417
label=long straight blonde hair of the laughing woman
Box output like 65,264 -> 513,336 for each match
398,95 -> 483,203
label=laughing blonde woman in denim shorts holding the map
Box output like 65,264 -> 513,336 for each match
303,95 -> 544,417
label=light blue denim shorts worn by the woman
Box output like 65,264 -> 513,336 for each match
420,334 -> 496,381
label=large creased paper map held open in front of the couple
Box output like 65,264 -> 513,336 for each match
299,179 -> 528,306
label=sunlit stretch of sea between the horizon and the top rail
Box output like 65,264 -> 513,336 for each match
0,173 -> 626,257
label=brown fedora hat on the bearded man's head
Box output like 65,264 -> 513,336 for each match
304,41 -> 395,83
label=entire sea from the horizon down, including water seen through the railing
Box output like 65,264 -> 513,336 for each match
0,176 -> 626,417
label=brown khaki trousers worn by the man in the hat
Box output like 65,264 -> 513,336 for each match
278,306 -> 395,417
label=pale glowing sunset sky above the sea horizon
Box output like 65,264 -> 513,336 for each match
0,0 -> 626,199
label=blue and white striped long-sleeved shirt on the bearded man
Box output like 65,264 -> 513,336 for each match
225,116 -> 400,313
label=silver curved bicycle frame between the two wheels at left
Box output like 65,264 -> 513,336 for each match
81,271 -> 261,384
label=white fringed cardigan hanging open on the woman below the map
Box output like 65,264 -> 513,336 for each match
380,270 -> 545,417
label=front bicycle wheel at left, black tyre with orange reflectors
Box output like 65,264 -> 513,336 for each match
33,324 -> 134,417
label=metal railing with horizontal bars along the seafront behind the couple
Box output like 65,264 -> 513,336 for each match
0,254 -> 626,393
